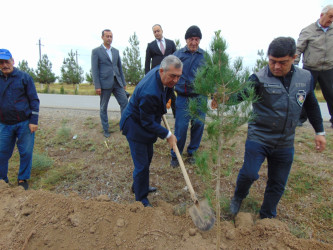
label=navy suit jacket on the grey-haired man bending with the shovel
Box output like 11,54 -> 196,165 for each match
119,67 -> 172,144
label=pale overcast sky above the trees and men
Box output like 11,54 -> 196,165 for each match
0,0 -> 333,80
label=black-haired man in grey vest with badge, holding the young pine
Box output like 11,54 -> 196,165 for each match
230,37 -> 326,219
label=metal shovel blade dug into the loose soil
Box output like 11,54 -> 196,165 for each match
189,199 -> 216,231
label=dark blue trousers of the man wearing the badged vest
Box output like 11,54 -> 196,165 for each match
235,141 -> 294,218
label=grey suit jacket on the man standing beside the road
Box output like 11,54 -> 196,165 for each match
91,45 -> 126,89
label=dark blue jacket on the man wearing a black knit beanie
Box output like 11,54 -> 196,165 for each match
173,46 -> 205,96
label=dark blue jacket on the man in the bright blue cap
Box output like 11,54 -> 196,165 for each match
0,68 -> 39,125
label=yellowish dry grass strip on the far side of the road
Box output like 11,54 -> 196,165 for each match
36,83 -> 326,102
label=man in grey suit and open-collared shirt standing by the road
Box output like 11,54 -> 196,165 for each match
91,29 -> 128,138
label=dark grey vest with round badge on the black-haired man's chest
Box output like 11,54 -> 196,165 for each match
247,66 -> 311,148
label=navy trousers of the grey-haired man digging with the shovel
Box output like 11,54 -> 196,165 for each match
127,138 -> 154,205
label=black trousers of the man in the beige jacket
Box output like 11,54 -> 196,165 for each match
299,68 -> 333,124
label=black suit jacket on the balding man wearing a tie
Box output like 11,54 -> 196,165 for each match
145,38 -> 176,74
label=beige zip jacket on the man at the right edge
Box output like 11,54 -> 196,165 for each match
295,21 -> 333,71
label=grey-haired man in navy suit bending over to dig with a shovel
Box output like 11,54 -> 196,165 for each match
119,55 -> 183,207
